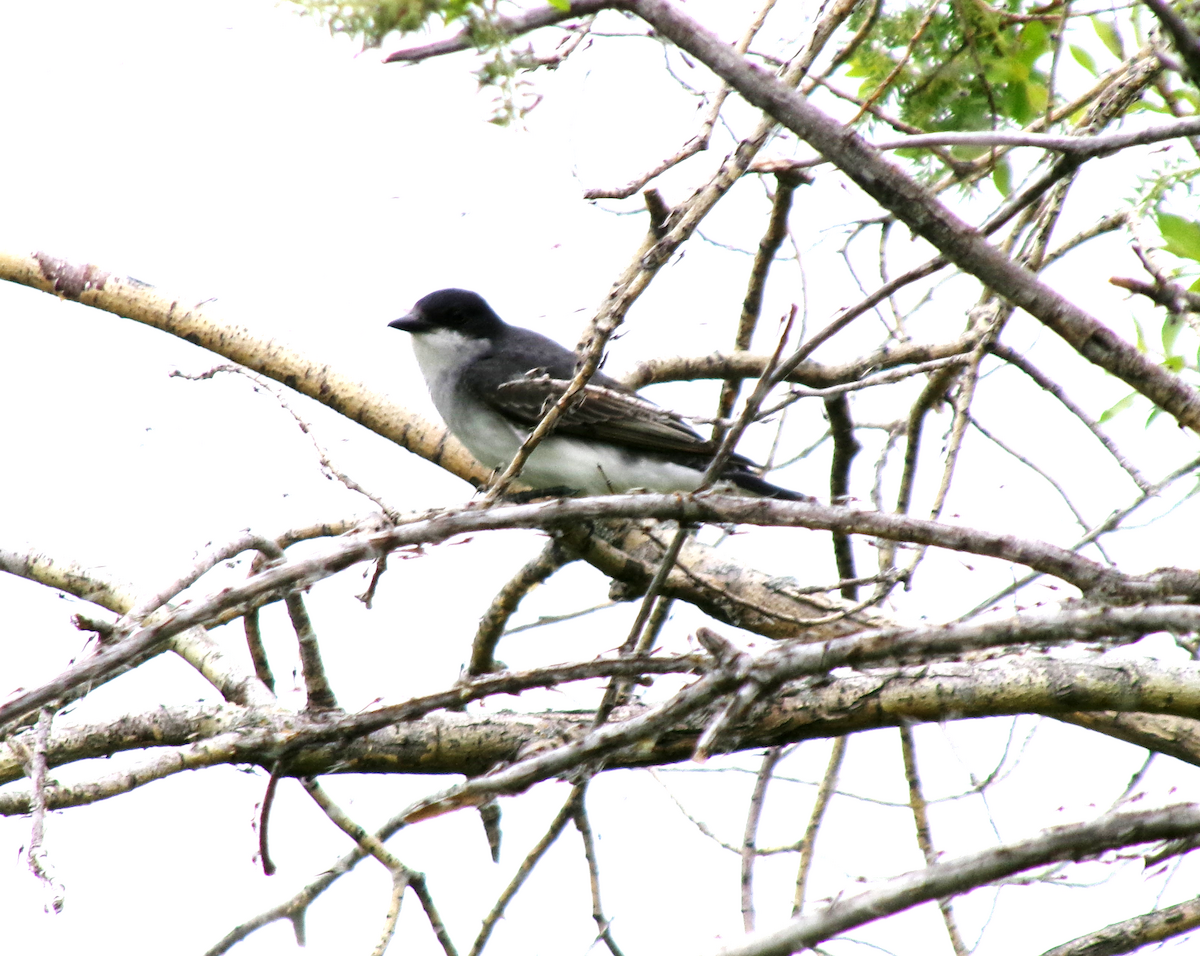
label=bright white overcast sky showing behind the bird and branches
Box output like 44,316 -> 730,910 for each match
0,0 -> 1198,956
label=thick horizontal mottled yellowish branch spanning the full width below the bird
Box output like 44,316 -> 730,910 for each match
11,654 -> 1200,814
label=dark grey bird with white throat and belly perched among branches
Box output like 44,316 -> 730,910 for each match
388,289 -> 812,501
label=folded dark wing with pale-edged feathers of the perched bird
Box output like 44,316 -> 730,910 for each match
480,368 -> 713,455
